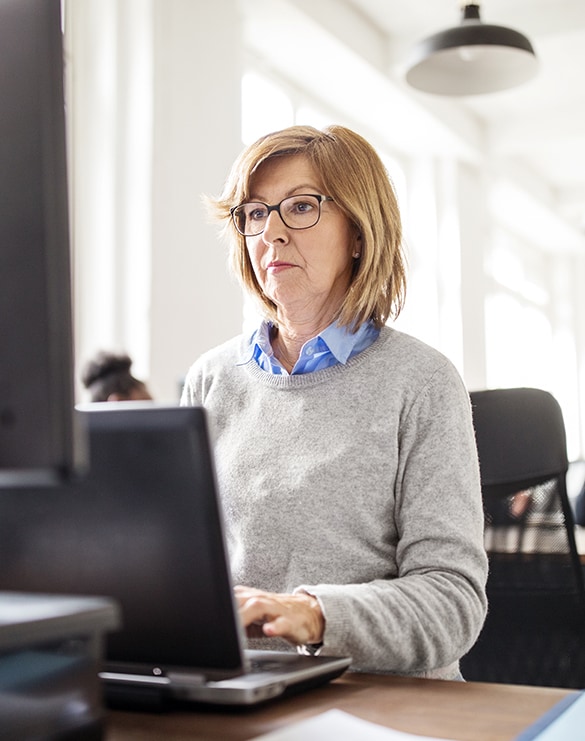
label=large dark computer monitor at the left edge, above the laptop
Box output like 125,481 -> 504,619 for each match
0,0 -> 84,486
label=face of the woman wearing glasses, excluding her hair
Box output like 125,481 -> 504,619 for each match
246,155 -> 360,323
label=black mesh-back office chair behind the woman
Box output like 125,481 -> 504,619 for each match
461,388 -> 585,688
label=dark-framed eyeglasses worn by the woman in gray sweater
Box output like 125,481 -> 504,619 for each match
230,193 -> 333,237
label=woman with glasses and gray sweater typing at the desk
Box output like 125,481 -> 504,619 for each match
182,126 -> 487,679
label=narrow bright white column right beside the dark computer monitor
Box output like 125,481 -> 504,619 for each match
65,0 -> 119,396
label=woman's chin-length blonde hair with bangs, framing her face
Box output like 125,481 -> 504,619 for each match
206,126 -> 406,331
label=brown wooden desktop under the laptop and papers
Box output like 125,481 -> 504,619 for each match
106,673 -> 570,741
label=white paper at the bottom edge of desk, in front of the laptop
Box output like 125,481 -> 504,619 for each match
252,710 -> 454,741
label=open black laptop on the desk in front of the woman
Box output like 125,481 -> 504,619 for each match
0,402 -> 350,705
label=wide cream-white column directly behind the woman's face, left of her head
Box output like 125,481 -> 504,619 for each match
150,0 -> 243,401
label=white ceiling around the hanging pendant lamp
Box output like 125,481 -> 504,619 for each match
345,0 -> 585,233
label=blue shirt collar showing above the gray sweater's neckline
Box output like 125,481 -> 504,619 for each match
237,321 -> 380,376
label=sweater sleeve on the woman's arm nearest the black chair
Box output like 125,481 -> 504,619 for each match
299,362 -> 487,678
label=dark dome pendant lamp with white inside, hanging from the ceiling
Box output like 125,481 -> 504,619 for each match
406,3 -> 538,96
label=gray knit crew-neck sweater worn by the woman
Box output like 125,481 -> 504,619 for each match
182,327 -> 487,679
